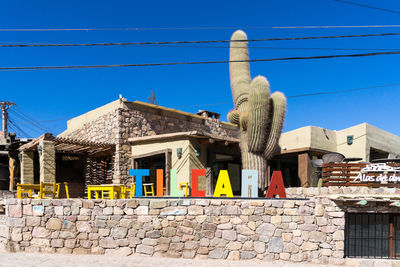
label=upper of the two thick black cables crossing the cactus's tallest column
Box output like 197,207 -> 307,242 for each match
0,32 -> 400,47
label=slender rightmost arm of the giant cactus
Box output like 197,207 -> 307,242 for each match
264,92 -> 286,159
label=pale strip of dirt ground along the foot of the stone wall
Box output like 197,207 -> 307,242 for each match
0,252 -> 352,267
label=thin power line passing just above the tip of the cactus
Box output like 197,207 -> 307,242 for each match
0,24 -> 400,32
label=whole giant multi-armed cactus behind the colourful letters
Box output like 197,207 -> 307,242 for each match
228,30 -> 286,194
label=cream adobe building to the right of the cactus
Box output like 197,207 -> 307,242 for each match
276,123 -> 400,187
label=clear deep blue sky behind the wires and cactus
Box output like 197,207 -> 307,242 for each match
0,0 -> 400,137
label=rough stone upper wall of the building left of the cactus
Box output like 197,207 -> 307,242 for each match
62,102 -> 239,183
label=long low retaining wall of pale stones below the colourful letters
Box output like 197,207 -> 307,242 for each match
0,189 -> 354,264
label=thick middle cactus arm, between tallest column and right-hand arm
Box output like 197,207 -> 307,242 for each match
247,76 -> 269,153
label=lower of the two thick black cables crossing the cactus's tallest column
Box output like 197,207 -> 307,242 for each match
0,51 -> 400,71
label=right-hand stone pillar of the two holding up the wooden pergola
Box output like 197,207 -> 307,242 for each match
38,140 -> 56,183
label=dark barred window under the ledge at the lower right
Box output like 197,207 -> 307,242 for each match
345,213 -> 400,258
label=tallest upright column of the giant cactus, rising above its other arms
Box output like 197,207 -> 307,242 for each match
229,30 -> 251,112
